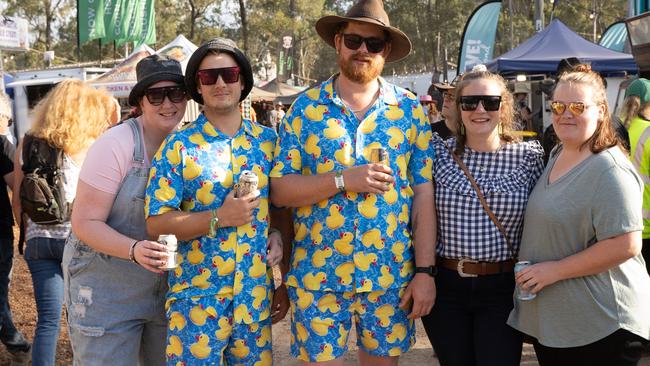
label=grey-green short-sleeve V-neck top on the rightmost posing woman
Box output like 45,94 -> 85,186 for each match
508,147 -> 650,348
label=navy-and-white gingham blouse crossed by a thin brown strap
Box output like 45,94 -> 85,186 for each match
432,134 -> 544,262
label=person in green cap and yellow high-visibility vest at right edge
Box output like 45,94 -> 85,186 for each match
621,78 -> 650,271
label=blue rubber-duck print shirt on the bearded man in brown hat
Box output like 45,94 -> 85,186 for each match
271,76 -> 434,292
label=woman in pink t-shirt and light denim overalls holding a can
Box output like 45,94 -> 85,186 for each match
63,55 -> 187,366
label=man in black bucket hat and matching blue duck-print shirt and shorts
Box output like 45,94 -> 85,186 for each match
145,38 -> 282,365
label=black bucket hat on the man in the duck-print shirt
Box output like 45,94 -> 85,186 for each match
185,37 -> 253,104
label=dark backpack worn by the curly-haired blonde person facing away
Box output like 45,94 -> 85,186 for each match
20,135 -> 70,225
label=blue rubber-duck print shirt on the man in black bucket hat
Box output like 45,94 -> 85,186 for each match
145,114 -> 277,324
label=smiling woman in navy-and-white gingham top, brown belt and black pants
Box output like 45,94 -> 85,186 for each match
423,71 -> 543,366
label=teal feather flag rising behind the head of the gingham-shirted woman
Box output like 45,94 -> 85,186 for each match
458,0 -> 501,73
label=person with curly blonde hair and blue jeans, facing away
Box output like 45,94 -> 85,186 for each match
13,79 -> 112,366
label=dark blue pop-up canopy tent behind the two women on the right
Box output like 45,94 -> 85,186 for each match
487,19 -> 638,75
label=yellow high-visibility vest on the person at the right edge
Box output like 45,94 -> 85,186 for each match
628,116 -> 650,239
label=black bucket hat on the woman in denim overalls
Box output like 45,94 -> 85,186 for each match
129,54 -> 185,107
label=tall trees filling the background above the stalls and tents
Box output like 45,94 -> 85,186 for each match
0,0 -> 627,83
